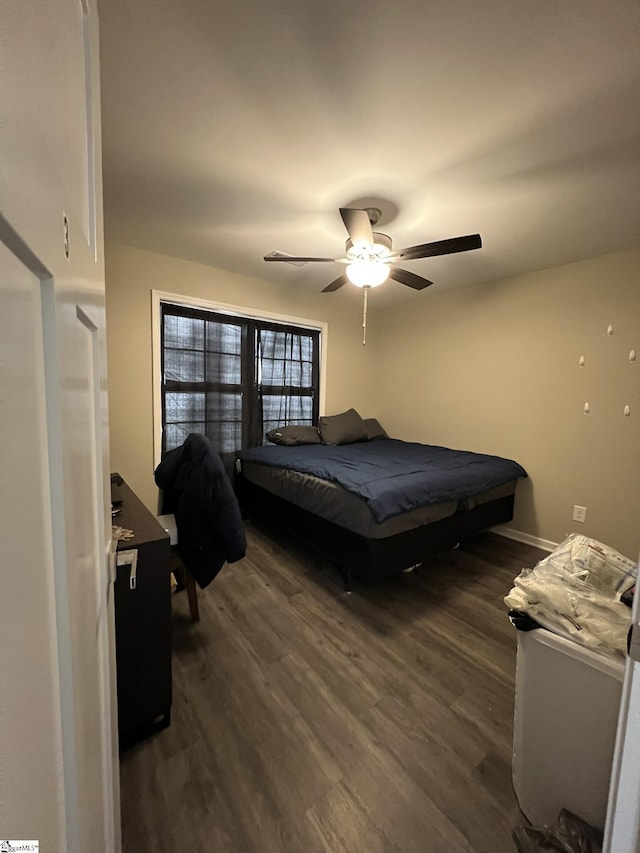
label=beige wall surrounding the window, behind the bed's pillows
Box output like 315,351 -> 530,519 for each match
106,244 -> 375,511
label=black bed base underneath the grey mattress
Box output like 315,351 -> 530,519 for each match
238,477 -> 514,589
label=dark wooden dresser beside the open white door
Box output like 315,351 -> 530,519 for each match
111,474 -> 171,748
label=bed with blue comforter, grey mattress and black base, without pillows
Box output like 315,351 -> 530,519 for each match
238,414 -> 527,588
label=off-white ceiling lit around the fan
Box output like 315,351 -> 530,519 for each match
99,0 -> 640,299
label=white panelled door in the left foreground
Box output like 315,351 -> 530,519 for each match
0,0 -> 120,853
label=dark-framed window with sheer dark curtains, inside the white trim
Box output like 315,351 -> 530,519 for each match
161,302 -> 320,454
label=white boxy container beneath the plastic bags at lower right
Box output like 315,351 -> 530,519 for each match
513,628 -> 625,829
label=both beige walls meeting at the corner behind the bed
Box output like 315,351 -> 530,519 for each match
106,245 -> 640,559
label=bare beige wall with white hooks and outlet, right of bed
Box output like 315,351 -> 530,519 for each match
373,243 -> 640,559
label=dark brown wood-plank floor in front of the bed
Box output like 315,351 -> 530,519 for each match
120,525 -> 542,853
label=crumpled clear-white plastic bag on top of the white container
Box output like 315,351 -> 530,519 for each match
504,533 -> 637,654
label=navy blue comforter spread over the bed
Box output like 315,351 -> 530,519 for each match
242,438 -> 527,522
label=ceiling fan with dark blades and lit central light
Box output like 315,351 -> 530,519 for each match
264,207 -> 482,293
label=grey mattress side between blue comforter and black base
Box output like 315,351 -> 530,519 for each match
242,460 -> 517,539
